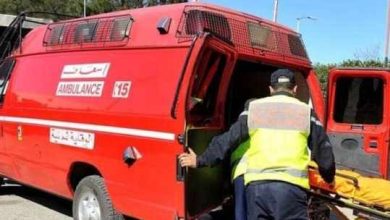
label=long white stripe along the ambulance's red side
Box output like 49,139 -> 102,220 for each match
0,116 -> 175,141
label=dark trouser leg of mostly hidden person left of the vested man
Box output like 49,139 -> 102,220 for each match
233,175 -> 247,220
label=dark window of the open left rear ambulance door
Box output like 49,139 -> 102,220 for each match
189,50 -> 226,126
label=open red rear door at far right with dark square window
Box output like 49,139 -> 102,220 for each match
327,69 -> 390,179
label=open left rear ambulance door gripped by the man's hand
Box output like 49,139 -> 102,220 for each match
185,36 -> 237,219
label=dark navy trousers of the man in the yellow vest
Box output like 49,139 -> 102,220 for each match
246,181 -> 309,220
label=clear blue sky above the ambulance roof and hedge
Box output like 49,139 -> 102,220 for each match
204,0 -> 387,64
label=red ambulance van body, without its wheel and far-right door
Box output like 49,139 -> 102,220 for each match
0,3 -> 326,219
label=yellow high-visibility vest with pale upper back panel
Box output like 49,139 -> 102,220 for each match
244,95 -> 310,188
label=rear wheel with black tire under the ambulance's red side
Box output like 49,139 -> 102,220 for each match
73,175 -> 124,220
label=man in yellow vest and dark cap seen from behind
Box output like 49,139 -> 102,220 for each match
180,69 -> 335,220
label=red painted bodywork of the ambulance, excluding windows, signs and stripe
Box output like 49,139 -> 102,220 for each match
0,4 -> 324,219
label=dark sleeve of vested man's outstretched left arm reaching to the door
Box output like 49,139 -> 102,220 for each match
197,111 -> 249,167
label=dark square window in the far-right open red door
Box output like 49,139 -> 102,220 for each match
334,77 -> 384,124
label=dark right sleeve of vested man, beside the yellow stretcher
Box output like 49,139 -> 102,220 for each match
308,110 -> 336,183
